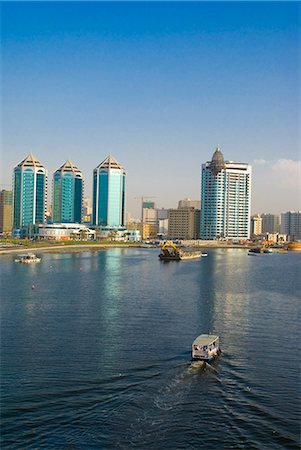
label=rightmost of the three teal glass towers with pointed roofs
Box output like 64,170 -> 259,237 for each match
93,155 -> 126,227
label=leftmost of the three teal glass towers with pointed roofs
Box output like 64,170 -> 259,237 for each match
13,153 -> 47,229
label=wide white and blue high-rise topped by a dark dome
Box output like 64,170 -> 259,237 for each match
200,148 -> 251,240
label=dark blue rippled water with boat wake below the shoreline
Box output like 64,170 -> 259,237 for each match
0,249 -> 301,450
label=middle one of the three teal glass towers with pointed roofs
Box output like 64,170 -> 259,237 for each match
52,160 -> 84,223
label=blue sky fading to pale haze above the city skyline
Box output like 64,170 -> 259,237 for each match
1,2 -> 301,217
